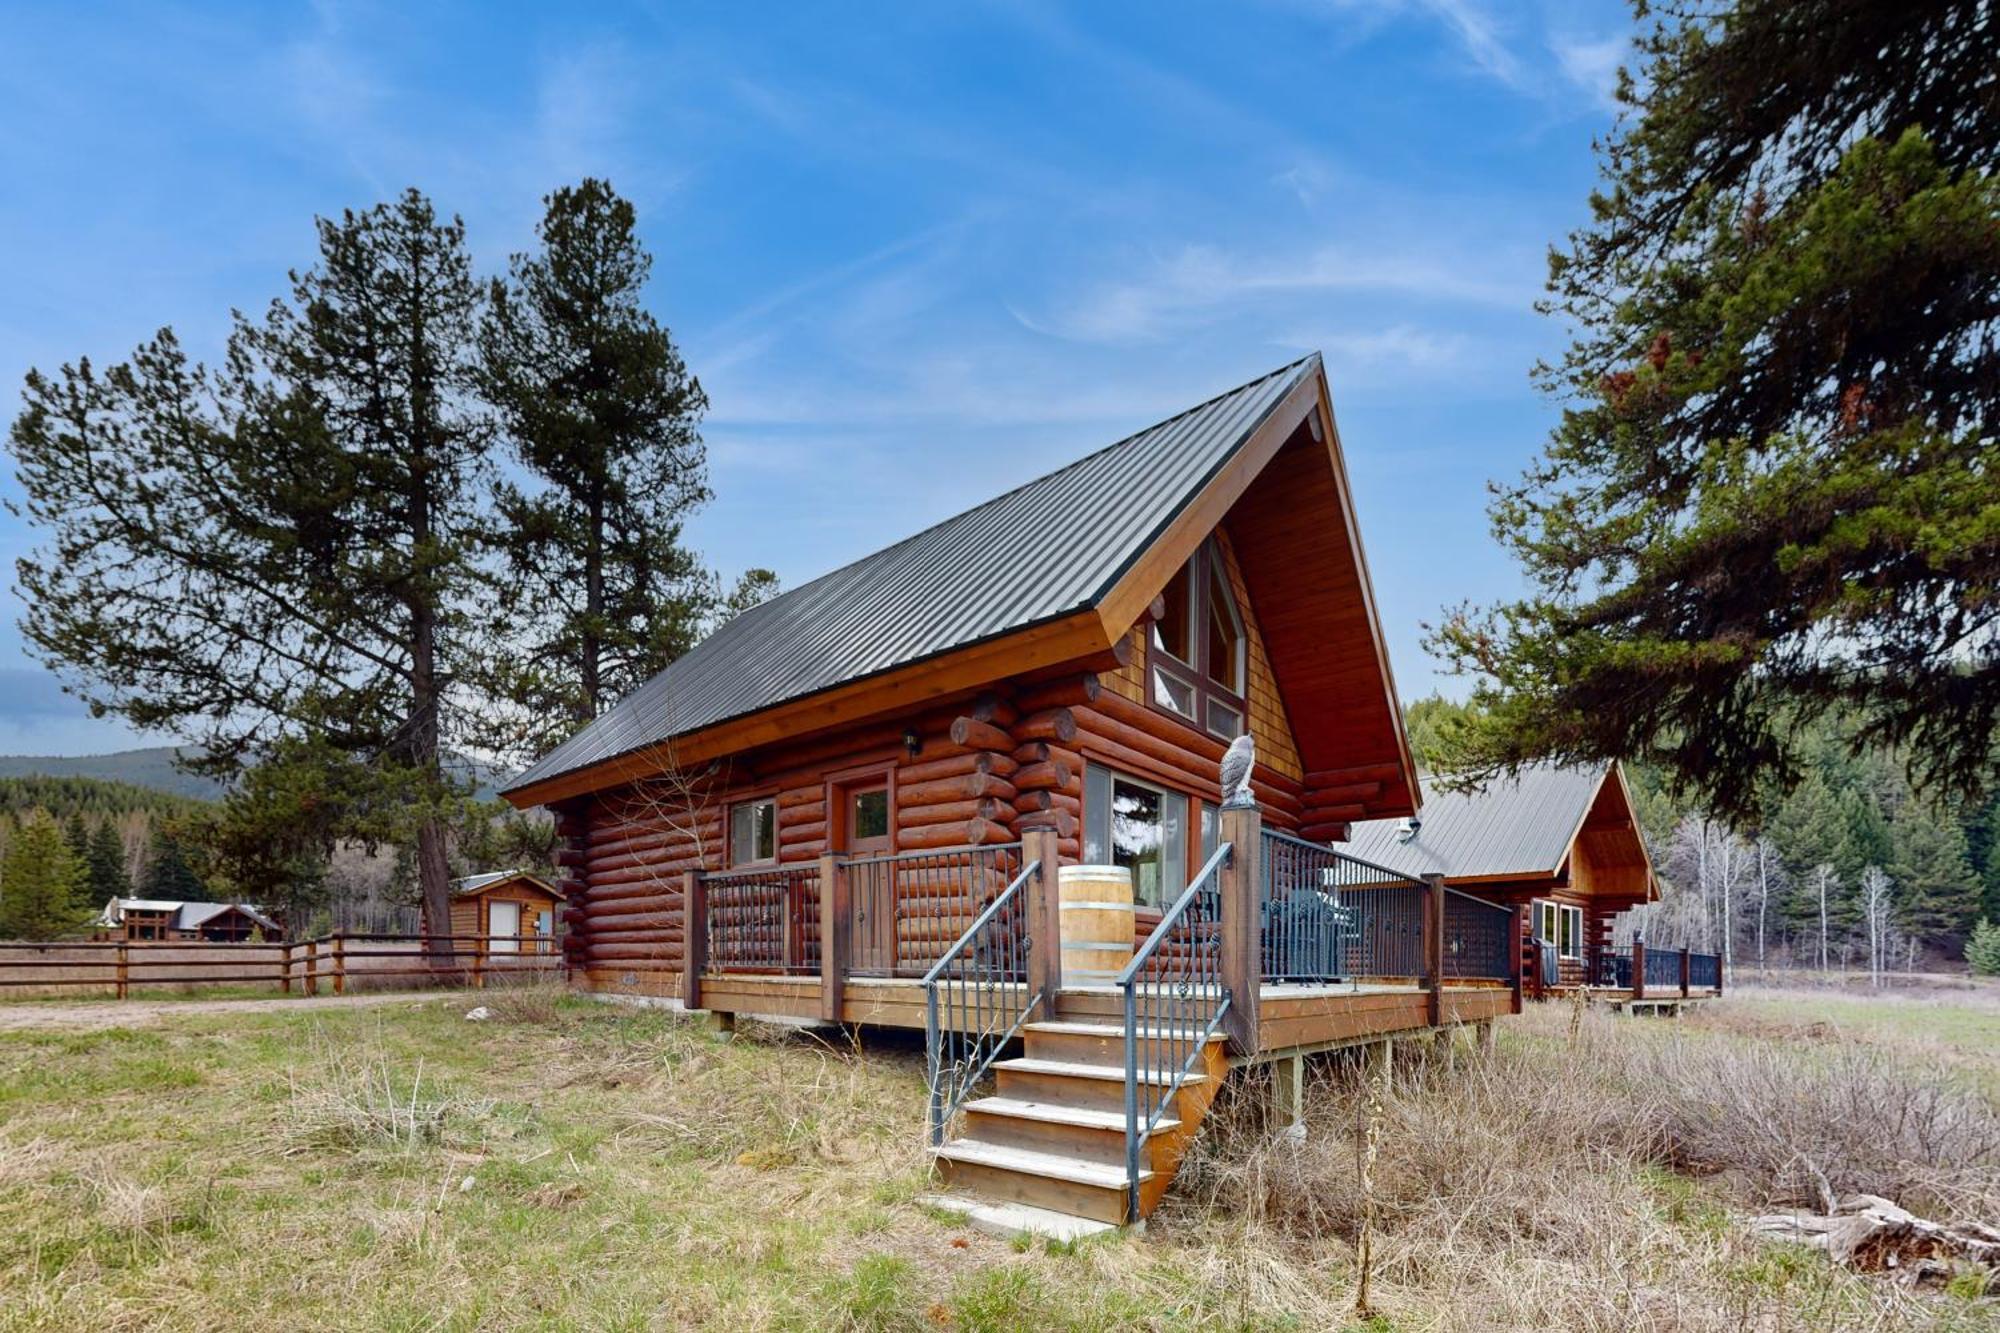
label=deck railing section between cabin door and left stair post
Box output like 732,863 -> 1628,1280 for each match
840,843 -> 1020,977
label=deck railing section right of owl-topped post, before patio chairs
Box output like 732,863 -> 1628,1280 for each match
1258,829 -> 1428,983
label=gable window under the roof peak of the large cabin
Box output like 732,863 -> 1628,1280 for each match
1146,538 -> 1250,741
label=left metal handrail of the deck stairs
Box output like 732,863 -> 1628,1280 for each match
924,861 -> 1048,1147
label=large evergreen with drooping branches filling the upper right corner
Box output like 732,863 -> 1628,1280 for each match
1432,0 -> 2000,821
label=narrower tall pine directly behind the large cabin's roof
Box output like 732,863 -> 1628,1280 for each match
480,180 -> 716,755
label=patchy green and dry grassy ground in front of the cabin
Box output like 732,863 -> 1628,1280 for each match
0,991 -> 2000,1331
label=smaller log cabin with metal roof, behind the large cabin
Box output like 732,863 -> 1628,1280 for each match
1350,763 -> 1722,1003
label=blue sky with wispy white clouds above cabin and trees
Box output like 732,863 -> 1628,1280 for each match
0,0 -> 1632,753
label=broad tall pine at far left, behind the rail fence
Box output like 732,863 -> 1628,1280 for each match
10,190 -> 488,948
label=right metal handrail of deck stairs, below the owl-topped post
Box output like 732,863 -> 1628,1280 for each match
1118,843 -> 1230,1223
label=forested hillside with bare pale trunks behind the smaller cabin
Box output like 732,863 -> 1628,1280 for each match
1408,699 -> 2000,969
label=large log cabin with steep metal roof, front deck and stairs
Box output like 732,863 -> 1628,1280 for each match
504,354 -> 1520,1223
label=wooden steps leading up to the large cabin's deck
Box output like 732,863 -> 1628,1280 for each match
932,989 -> 1228,1233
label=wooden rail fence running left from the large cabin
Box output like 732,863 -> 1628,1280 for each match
0,933 -> 564,999
